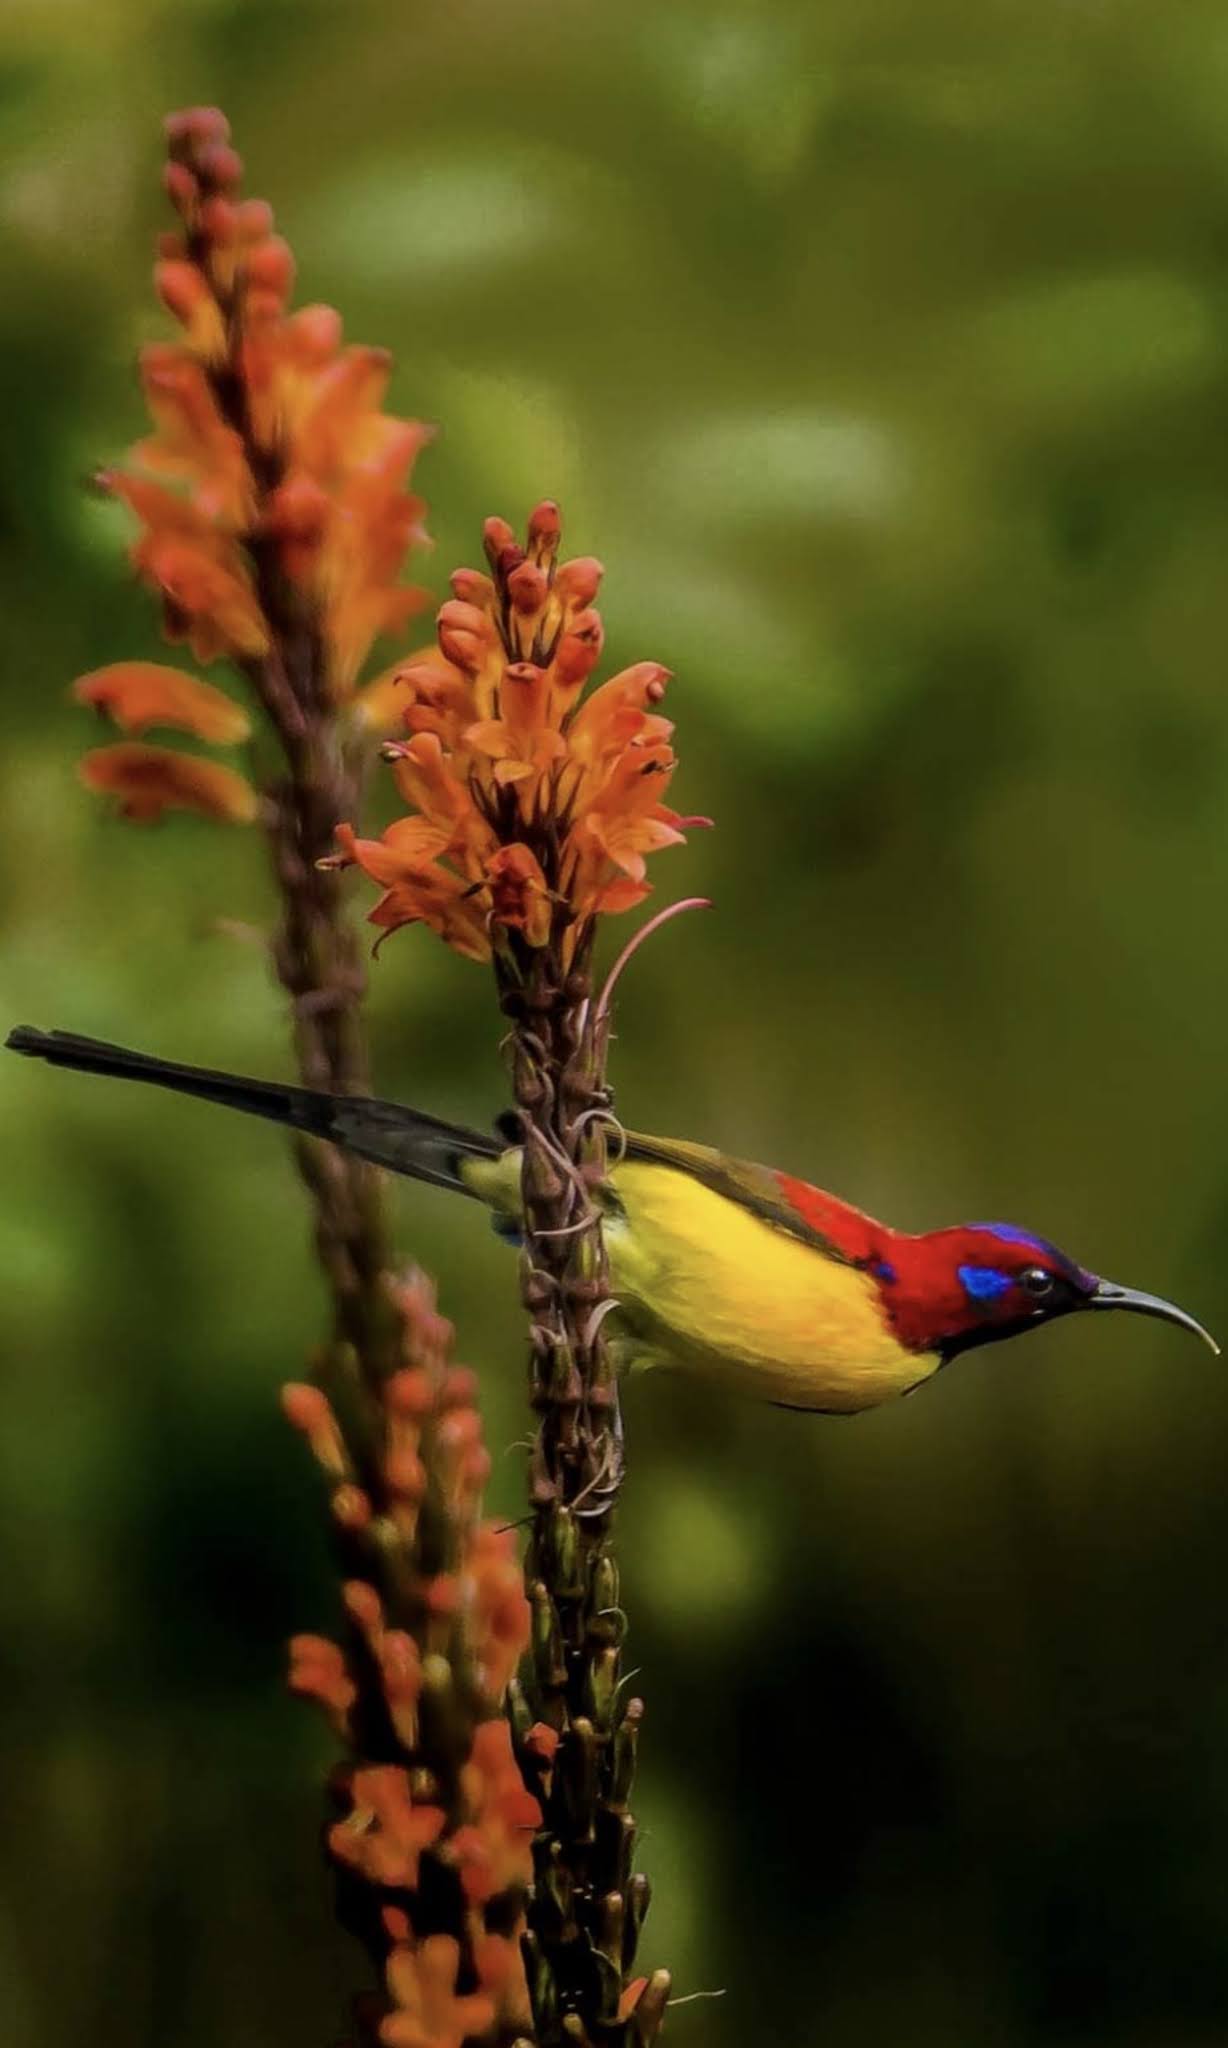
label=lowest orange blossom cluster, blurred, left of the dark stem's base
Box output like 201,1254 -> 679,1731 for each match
282,1274 -> 551,2048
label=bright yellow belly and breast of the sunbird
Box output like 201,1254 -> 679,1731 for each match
606,1161 -> 939,1413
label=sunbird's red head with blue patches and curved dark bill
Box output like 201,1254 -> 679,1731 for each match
870,1223 -> 1216,1358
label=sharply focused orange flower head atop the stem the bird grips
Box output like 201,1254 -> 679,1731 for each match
342,502 -> 686,963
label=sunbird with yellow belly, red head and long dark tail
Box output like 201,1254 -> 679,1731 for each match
8,1024 -> 1218,1415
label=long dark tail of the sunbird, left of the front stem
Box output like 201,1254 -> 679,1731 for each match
6,1024 -> 503,1194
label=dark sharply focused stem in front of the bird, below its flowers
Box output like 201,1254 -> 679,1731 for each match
499,930 -> 669,2048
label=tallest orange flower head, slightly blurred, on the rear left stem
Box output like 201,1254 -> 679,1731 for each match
78,106 -> 428,817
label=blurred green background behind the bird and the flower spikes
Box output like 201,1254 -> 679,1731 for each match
0,0 -> 1228,2048
